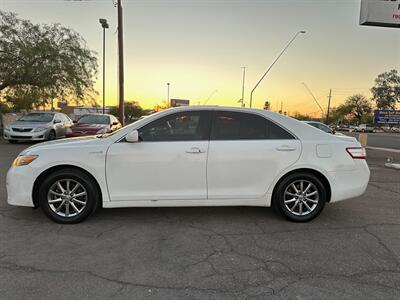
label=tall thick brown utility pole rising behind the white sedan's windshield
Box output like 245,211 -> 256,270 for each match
117,0 -> 125,126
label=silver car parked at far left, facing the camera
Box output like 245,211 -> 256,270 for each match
3,112 -> 73,143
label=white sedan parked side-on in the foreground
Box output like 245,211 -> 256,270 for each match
7,106 -> 370,223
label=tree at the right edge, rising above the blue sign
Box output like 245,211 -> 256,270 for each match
371,70 -> 400,109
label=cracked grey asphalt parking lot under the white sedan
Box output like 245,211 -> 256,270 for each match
0,141 -> 400,299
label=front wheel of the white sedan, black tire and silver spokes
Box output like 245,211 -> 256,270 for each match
39,169 -> 100,224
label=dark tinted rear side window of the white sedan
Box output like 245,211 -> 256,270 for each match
211,111 -> 294,140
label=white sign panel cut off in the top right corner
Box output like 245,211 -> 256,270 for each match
360,0 -> 400,28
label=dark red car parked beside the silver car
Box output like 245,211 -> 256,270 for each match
67,114 -> 122,137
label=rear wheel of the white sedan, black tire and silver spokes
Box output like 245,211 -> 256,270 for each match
272,172 -> 327,222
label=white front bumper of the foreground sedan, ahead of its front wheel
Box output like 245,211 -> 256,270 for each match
6,165 -> 36,207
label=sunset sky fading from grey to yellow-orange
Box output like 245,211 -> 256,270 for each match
0,0 -> 400,116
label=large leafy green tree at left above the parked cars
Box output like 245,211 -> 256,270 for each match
0,11 -> 97,106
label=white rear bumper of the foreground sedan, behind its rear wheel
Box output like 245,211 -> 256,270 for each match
329,160 -> 370,202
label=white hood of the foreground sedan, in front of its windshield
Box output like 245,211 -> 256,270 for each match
20,136 -> 108,155
